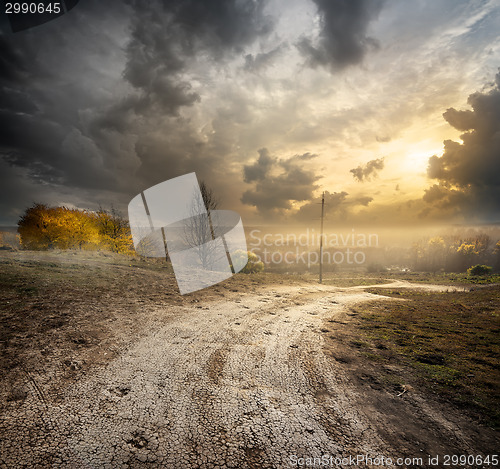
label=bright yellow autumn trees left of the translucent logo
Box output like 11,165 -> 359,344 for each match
18,204 -> 133,253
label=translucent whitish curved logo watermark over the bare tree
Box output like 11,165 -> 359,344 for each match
128,173 -> 248,295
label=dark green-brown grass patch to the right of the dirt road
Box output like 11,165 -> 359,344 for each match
357,286 -> 500,428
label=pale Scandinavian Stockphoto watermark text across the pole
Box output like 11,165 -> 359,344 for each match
249,228 -> 379,268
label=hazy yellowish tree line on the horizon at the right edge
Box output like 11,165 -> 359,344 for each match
411,234 -> 500,272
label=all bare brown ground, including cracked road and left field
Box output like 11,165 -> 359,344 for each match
0,252 -> 499,468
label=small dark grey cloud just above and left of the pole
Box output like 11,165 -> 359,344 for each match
241,148 -> 320,214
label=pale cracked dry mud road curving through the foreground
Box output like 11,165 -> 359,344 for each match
0,284 -> 496,468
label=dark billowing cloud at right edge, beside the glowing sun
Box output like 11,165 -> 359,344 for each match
424,72 -> 500,221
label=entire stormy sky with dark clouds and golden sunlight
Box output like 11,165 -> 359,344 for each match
0,0 -> 500,225
